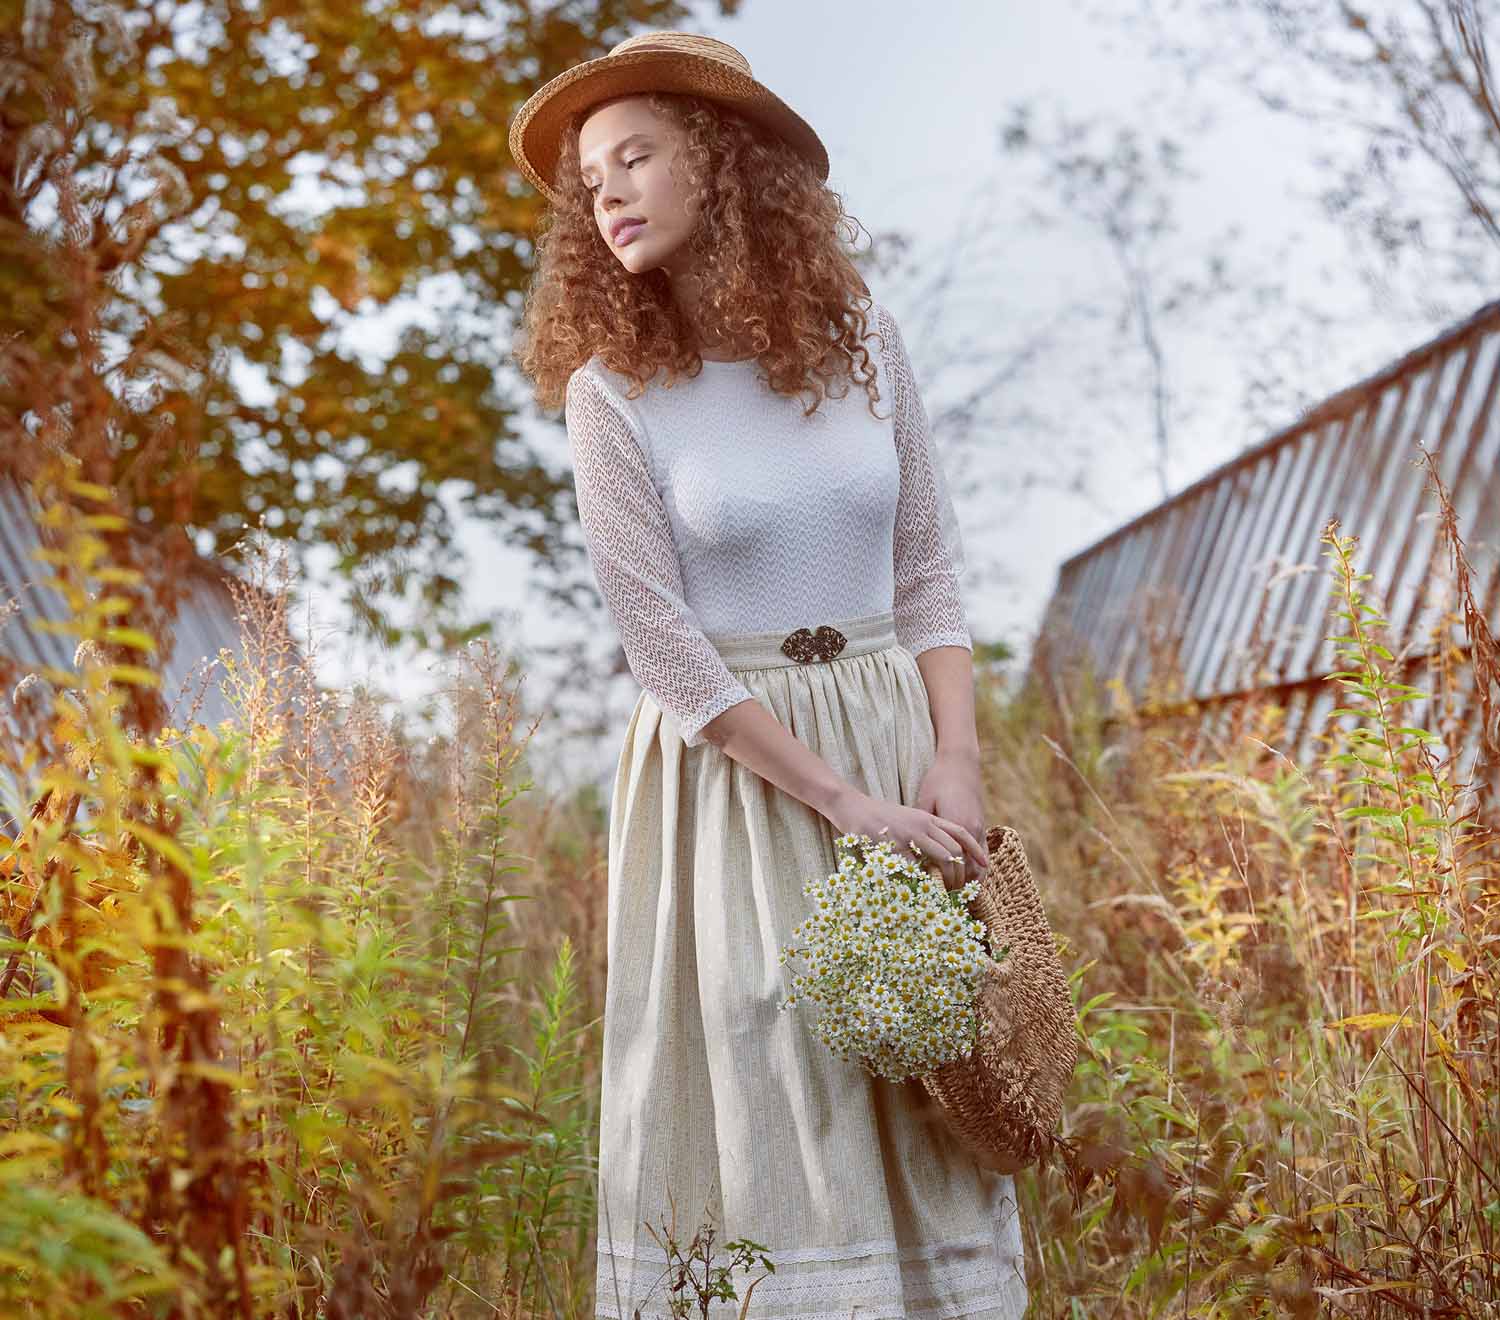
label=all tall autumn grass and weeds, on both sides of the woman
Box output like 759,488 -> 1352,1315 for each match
0,438 -> 1500,1317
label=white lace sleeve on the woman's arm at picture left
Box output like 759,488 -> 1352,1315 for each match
564,369 -> 755,747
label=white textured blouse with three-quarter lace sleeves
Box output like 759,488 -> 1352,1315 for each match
564,303 -> 974,747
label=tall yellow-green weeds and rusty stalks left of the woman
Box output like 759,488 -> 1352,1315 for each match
0,464 -> 594,1317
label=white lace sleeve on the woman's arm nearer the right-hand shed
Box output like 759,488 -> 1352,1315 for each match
876,303 -> 974,656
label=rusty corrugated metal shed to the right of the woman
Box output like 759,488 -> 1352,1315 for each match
1031,302 -> 1500,774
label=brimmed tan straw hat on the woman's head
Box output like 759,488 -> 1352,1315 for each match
510,32 -> 828,206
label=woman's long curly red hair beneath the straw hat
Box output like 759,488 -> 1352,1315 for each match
513,92 -> 879,414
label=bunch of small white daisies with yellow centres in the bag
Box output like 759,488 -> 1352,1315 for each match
780,834 -> 993,1082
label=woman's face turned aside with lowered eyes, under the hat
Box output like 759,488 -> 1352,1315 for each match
578,96 -> 698,275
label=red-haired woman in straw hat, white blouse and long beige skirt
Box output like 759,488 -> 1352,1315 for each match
510,33 -> 1026,1320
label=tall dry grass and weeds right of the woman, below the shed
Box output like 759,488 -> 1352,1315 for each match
1008,461 -> 1500,1317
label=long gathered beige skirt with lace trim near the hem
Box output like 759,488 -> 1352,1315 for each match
596,611 -> 1026,1320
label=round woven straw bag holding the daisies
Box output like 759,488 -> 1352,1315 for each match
920,825 -> 1079,1173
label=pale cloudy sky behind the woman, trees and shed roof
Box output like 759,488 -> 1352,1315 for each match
286,0 -> 1484,785
